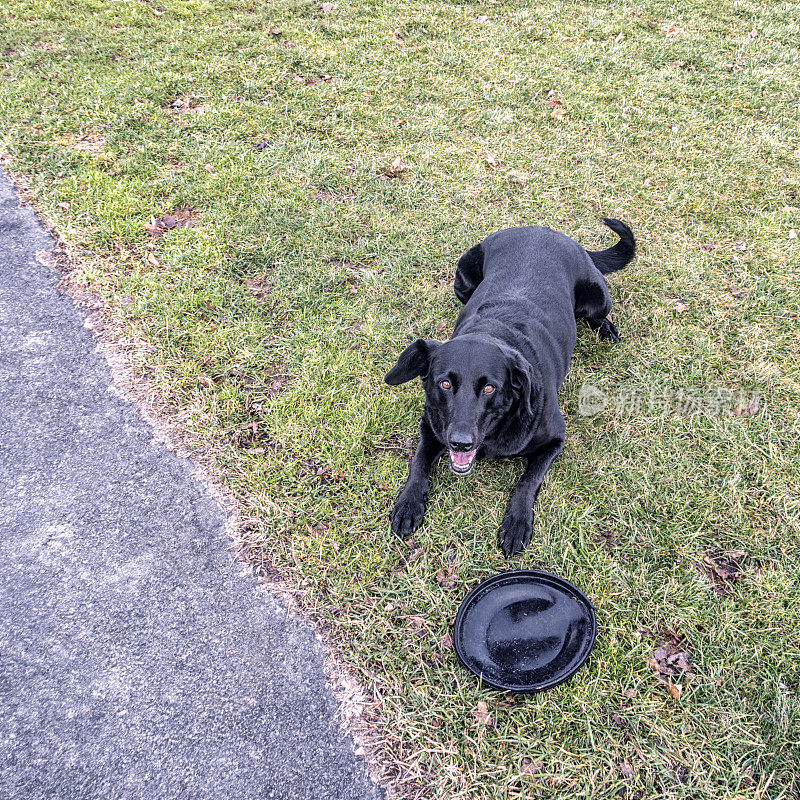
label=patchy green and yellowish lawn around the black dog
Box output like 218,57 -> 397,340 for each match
0,0 -> 800,800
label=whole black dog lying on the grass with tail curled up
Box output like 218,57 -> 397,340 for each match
386,219 -> 636,557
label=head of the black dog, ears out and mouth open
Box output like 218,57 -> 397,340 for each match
386,335 -> 534,475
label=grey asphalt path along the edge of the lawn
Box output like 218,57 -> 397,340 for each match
0,172 -> 381,800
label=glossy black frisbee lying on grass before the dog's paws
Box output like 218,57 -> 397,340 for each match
453,570 -> 597,692
